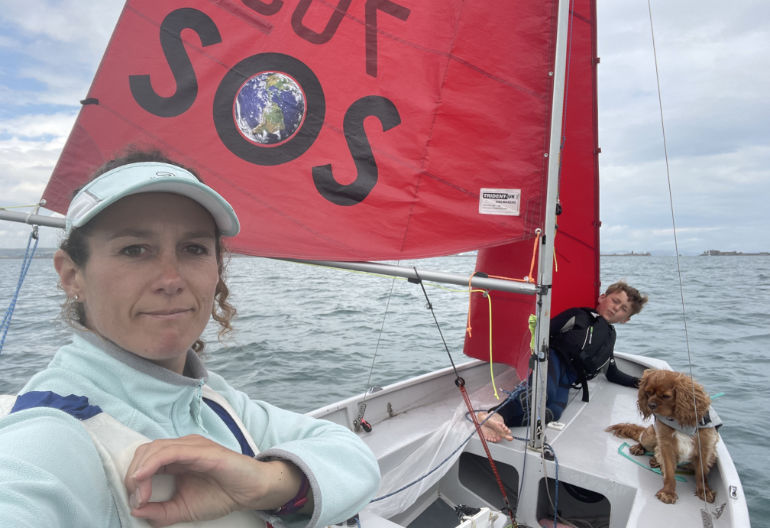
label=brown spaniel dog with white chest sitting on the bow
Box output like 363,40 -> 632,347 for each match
606,369 -> 721,504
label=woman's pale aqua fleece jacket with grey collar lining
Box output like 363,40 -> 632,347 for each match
0,331 -> 379,528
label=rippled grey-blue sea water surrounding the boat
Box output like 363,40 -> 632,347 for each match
0,255 -> 770,528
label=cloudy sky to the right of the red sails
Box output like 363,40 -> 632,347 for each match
599,1 -> 770,253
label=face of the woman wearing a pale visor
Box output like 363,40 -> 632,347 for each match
57,193 -> 219,373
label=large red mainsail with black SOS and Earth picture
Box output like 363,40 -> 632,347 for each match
44,0 -> 552,265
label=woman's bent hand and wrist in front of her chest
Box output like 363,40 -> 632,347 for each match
125,435 -> 312,526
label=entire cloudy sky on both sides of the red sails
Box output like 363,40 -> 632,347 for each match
0,0 -> 770,255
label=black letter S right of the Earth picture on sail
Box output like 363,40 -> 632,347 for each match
313,95 -> 401,205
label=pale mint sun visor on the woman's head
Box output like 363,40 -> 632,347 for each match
64,161 -> 240,236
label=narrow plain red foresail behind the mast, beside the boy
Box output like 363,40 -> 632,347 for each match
465,0 -> 600,373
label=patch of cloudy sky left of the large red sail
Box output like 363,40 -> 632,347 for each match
0,0 -> 123,247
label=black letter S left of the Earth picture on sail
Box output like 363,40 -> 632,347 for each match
128,8 -> 222,117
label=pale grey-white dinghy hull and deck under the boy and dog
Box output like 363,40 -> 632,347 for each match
311,353 -> 750,528
